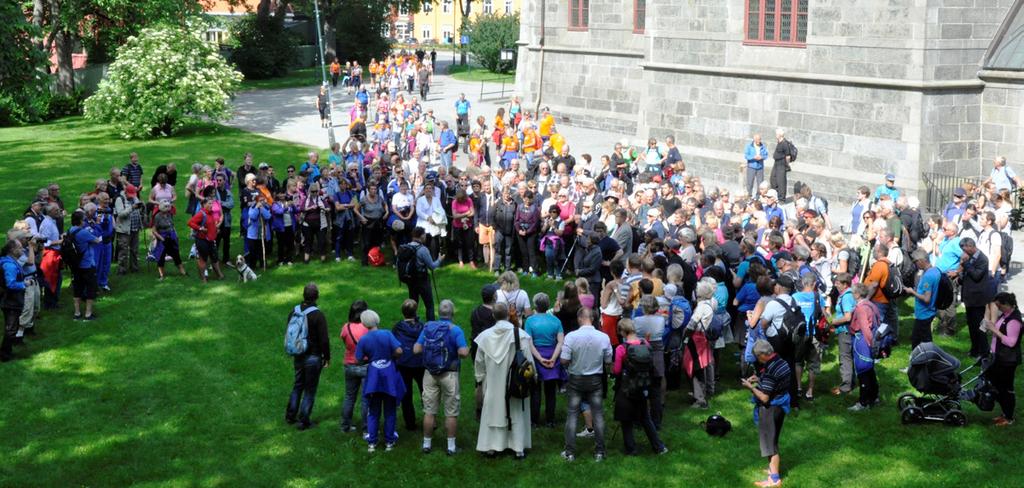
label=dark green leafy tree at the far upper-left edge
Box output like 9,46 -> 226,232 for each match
0,0 -> 48,126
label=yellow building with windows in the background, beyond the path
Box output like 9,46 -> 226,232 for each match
399,0 -> 522,44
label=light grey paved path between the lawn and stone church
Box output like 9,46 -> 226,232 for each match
227,54 -> 1024,296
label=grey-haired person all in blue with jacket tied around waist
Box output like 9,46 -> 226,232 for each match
355,310 -> 406,452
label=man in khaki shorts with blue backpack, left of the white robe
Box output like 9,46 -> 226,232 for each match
413,300 -> 469,455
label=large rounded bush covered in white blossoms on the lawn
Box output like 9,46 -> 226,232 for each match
85,27 -> 242,138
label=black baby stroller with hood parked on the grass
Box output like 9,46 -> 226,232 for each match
896,343 -> 995,427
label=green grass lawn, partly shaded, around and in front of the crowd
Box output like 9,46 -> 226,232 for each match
0,119 -> 1024,487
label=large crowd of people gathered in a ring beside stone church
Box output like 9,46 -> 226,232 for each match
0,66 -> 1021,486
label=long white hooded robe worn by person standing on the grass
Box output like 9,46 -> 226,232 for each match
474,320 -> 534,452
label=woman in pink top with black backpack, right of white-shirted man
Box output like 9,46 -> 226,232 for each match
611,318 -> 669,455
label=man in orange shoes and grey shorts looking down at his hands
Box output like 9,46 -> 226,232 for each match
741,339 -> 793,486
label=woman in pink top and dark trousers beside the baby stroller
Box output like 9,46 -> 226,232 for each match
985,293 -> 1021,427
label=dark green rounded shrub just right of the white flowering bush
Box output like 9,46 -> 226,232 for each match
231,14 -> 298,80
